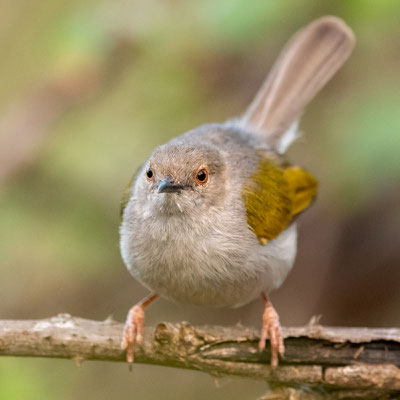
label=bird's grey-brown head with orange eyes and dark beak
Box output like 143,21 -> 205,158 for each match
125,144 -> 226,218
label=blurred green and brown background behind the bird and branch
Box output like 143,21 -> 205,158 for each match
0,0 -> 400,400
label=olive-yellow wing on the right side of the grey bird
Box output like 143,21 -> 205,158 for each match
243,158 -> 317,244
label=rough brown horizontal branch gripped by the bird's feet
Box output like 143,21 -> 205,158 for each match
0,314 -> 400,399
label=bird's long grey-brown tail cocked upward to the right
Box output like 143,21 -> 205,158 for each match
240,16 -> 355,153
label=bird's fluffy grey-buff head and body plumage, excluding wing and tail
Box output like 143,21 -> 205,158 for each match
121,124 -> 296,306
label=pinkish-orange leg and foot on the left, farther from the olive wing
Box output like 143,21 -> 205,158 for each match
121,293 -> 158,364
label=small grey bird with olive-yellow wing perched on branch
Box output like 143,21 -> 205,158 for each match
120,16 -> 354,366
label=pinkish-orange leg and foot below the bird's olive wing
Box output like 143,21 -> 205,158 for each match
258,293 -> 285,367
